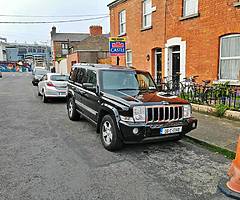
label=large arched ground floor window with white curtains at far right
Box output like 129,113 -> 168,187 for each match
219,34 -> 240,80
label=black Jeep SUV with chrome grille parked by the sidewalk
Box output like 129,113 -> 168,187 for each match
67,64 -> 197,150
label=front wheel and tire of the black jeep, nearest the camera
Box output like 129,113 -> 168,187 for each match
100,115 -> 123,151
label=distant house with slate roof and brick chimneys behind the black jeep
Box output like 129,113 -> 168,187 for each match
51,25 -> 110,73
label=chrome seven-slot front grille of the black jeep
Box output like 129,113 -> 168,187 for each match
146,105 -> 183,123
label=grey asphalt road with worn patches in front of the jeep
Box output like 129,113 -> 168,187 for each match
0,73 -> 231,200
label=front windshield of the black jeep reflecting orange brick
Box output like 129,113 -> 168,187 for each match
102,70 -> 156,91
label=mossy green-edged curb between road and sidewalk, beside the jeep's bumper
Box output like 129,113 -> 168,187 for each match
185,135 -> 236,160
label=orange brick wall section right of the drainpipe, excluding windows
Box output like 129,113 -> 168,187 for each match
166,0 -> 240,80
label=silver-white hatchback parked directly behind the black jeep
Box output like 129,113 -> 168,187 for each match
38,73 -> 69,103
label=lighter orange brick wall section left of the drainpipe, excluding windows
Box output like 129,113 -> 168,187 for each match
110,0 -> 164,72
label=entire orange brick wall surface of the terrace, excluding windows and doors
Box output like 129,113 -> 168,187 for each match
110,0 -> 240,80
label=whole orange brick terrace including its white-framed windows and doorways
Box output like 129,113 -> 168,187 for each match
108,0 -> 240,84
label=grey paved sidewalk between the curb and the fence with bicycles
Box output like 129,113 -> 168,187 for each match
187,112 -> 240,152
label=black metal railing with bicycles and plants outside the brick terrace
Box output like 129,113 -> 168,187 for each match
162,83 -> 240,111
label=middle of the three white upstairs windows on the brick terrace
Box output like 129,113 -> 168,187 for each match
143,0 -> 152,28
